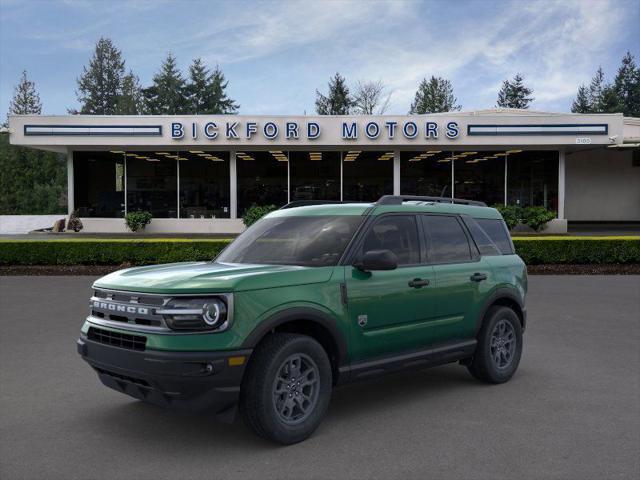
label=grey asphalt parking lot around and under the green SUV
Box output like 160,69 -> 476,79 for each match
0,276 -> 640,480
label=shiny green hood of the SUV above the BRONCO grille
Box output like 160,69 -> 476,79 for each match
94,262 -> 333,294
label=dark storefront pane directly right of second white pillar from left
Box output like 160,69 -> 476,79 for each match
236,151 -> 288,216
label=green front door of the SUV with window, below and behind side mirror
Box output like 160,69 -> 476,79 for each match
345,214 -> 434,361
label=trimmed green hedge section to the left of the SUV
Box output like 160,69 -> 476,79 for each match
0,238 -> 231,265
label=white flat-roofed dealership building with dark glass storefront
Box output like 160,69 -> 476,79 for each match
9,109 -> 640,233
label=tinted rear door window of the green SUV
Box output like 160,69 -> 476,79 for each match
422,215 -> 471,263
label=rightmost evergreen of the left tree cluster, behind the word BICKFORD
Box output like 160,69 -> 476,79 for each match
186,58 -> 239,114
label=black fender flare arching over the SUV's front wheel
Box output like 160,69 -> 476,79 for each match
242,307 -> 348,366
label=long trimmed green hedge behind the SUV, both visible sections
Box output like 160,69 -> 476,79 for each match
0,236 -> 640,265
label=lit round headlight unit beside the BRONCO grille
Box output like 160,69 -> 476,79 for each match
156,297 -> 227,331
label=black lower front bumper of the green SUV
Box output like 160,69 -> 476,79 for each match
77,335 -> 251,413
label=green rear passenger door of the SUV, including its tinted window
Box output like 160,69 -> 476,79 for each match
421,214 -> 492,342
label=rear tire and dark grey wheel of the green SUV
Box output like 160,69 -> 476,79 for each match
467,306 -> 522,383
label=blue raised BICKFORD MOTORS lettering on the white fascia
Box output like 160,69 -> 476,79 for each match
171,120 -> 460,140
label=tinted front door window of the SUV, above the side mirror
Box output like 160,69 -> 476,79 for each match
362,215 -> 420,265
